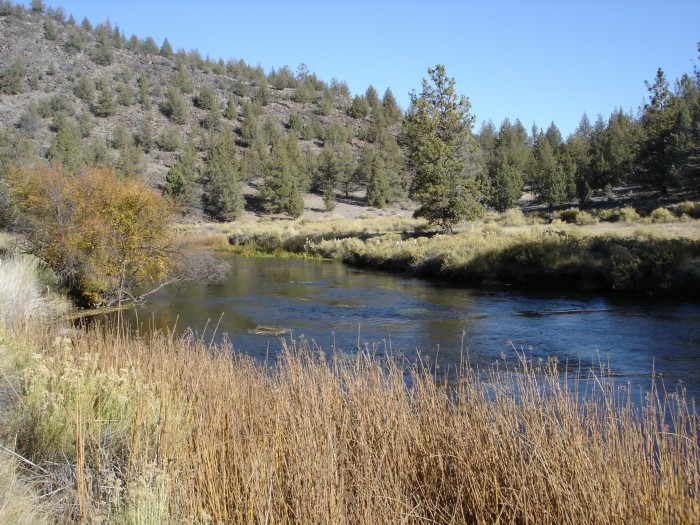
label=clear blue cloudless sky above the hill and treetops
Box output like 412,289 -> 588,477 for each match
30,0 -> 700,136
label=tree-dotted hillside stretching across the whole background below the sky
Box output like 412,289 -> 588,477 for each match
0,0 -> 700,222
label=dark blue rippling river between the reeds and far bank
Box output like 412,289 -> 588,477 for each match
121,255 -> 700,400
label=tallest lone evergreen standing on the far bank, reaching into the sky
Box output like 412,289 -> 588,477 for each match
404,65 -> 483,230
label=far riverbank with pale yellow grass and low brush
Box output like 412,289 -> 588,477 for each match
183,208 -> 700,297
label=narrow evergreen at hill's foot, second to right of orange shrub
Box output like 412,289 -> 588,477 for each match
204,126 -> 243,221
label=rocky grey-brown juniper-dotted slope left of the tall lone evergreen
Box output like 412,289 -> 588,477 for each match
0,2 -> 403,219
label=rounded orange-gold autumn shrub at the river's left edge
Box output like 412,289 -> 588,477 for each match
7,166 -> 175,305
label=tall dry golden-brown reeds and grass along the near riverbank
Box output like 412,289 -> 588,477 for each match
0,248 -> 700,524
